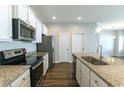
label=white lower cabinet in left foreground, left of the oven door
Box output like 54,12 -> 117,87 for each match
10,70 -> 31,87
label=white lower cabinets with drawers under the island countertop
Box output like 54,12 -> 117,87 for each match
76,59 -> 108,87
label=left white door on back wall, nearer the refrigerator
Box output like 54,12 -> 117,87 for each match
59,32 -> 69,62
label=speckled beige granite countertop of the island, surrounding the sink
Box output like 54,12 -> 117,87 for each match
73,53 -> 124,87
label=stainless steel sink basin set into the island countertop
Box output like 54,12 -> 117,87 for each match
81,56 -> 109,65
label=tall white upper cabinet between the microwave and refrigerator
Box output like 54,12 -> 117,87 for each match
34,18 -> 42,43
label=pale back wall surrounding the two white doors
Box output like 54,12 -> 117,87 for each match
47,23 -> 99,61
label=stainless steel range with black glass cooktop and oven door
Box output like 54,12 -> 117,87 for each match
0,49 -> 43,87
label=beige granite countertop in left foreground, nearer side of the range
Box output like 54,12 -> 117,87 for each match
0,65 -> 30,87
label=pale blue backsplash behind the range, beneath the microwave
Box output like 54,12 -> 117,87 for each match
0,41 -> 36,52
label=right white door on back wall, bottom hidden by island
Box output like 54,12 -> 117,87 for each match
72,33 -> 84,52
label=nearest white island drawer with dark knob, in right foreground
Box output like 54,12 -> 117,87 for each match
91,72 -> 108,87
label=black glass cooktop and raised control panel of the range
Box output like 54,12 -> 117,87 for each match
0,49 -> 43,65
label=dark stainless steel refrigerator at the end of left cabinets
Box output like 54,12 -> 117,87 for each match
37,34 -> 55,68
